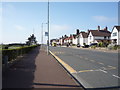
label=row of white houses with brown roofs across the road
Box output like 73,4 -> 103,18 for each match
51,26 -> 120,46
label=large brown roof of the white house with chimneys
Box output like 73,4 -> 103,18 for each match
89,30 -> 111,37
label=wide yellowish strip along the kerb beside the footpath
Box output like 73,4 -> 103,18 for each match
49,51 -> 77,73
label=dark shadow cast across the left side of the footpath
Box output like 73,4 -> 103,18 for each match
2,47 -> 40,89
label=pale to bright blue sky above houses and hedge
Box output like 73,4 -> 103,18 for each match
0,2 -> 118,44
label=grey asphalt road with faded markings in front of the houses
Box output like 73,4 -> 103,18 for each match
50,47 -> 120,90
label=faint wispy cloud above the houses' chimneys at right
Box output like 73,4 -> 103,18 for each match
93,16 -> 117,23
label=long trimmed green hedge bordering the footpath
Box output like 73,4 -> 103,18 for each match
2,45 -> 38,64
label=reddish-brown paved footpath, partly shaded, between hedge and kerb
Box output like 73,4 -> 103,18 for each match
2,47 -> 84,90
